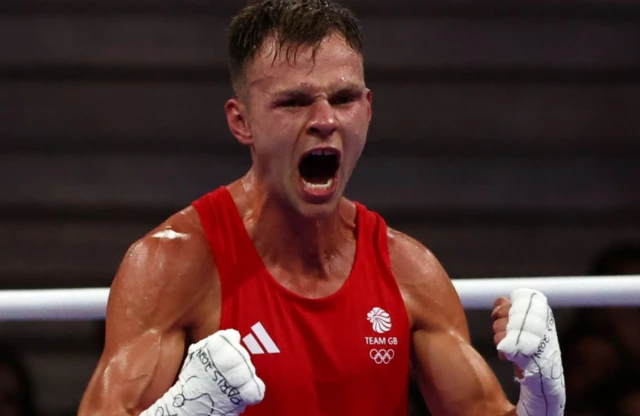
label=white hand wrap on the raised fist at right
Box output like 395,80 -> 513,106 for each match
498,289 -> 566,416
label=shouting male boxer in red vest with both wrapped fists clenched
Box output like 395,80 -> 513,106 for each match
80,0 -> 564,416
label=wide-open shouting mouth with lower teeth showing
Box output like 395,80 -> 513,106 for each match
298,149 -> 340,191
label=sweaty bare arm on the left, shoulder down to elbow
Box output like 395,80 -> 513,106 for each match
79,214 -> 218,416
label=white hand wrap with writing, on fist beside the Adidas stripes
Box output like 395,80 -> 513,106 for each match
140,329 -> 265,416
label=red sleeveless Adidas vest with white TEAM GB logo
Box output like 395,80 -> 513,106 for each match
193,187 -> 410,416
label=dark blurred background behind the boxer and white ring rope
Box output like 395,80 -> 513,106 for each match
0,0 -> 640,416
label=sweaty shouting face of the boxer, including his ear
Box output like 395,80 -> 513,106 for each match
225,35 -> 371,218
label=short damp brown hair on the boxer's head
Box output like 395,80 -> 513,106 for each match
227,0 -> 364,93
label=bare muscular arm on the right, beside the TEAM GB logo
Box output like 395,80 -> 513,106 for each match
389,230 -> 516,416
